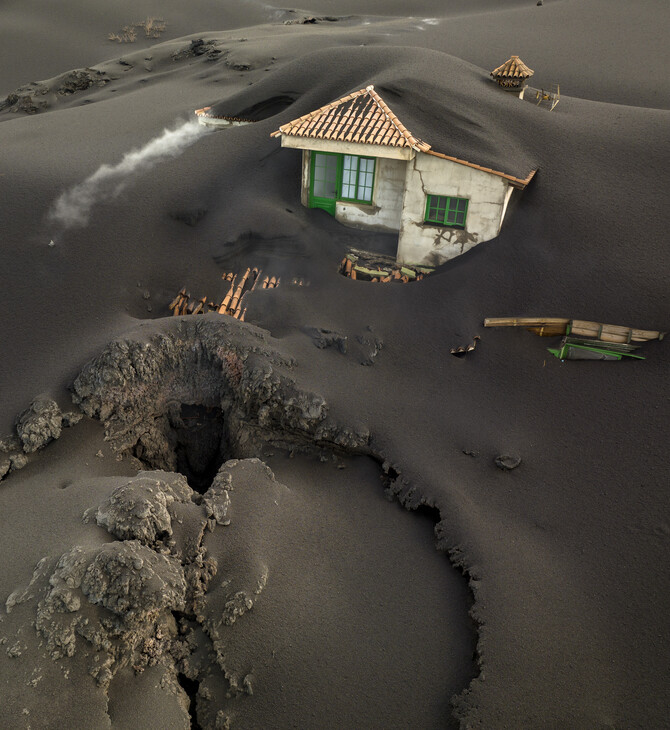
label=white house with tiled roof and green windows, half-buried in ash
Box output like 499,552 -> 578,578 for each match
272,86 -> 535,266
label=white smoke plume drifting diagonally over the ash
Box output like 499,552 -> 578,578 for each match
49,121 -> 211,228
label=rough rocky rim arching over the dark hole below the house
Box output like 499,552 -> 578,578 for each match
72,315 -> 370,471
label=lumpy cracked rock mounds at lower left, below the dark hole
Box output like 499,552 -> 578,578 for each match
6,459 -> 276,727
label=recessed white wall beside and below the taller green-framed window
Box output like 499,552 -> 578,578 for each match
335,157 -> 407,231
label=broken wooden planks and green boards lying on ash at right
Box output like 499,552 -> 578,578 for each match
484,317 -> 665,360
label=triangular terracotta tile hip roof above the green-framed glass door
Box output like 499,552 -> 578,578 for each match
272,86 -> 430,152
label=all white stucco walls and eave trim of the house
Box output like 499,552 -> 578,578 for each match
282,135 -> 513,266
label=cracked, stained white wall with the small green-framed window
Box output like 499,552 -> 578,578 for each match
398,152 -> 509,266
